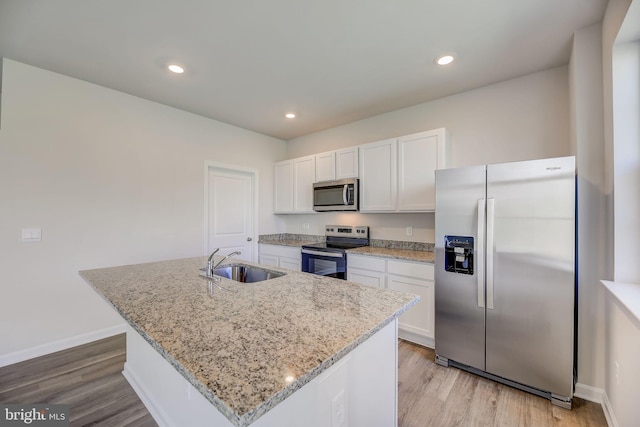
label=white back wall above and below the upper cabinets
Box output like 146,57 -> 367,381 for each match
281,67 -> 571,243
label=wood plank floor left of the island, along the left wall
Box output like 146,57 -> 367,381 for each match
0,334 -> 157,427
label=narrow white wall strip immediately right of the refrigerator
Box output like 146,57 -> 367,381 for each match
569,24 -> 608,393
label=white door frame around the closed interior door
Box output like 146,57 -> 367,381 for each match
202,160 -> 259,262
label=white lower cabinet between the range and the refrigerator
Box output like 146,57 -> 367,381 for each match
347,254 -> 435,348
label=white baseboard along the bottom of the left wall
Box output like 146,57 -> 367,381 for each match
0,323 -> 126,368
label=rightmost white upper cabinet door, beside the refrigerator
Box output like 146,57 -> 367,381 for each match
398,129 -> 448,212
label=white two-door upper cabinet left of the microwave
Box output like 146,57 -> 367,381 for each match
274,156 -> 316,213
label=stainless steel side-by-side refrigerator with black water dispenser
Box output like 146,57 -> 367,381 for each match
435,157 -> 577,408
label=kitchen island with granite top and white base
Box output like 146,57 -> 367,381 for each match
80,257 -> 417,427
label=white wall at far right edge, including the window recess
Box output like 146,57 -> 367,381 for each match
603,0 -> 640,427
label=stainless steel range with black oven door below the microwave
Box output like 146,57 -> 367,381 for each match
302,225 -> 369,280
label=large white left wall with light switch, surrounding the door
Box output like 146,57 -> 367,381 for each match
0,59 -> 285,364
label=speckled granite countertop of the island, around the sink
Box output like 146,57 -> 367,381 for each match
80,257 -> 418,427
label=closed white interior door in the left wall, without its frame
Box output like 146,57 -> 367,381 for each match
205,164 -> 256,261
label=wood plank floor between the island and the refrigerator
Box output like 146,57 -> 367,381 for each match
398,340 -> 607,427
